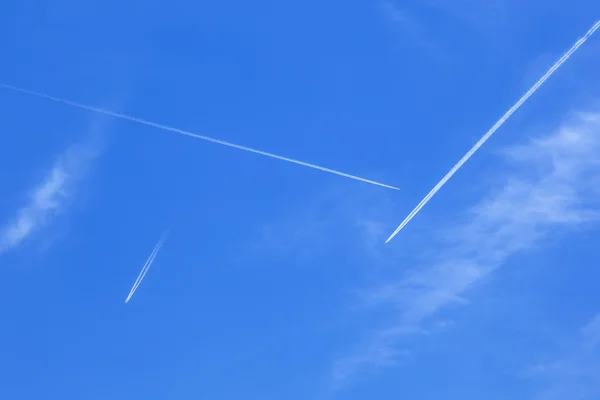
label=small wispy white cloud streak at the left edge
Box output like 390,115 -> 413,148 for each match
0,129 -> 102,254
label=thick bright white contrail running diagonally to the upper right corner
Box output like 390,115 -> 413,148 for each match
385,20 -> 600,243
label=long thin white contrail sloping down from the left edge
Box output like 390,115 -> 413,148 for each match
0,83 -> 399,190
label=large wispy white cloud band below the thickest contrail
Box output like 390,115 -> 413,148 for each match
333,108 -> 600,385
